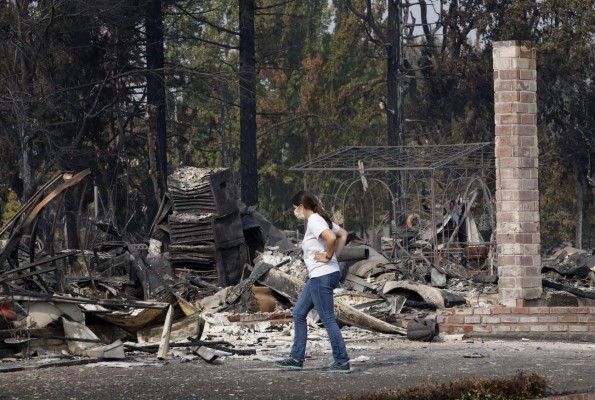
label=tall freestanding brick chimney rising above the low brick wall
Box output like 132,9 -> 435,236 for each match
493,40 -> 542,307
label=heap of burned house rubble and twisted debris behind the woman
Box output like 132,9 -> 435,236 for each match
0,167 -> 595,368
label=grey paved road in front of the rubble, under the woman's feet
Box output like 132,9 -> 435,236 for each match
0,339 -> 595,400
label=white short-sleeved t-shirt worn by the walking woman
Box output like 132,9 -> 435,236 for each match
302,213 -> 341,278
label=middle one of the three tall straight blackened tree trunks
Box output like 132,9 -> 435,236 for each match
240,0 -> 258,206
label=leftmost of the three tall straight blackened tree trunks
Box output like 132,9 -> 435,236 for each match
145,0 -> 167,223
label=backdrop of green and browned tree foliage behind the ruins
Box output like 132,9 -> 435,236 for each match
0,0 -> 595,246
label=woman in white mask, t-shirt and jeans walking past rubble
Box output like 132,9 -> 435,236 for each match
275,191 -> 351,373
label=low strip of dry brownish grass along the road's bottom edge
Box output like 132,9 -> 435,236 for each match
342,372 -> 548,400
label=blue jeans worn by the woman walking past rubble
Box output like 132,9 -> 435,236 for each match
291,271 -> 349,363
